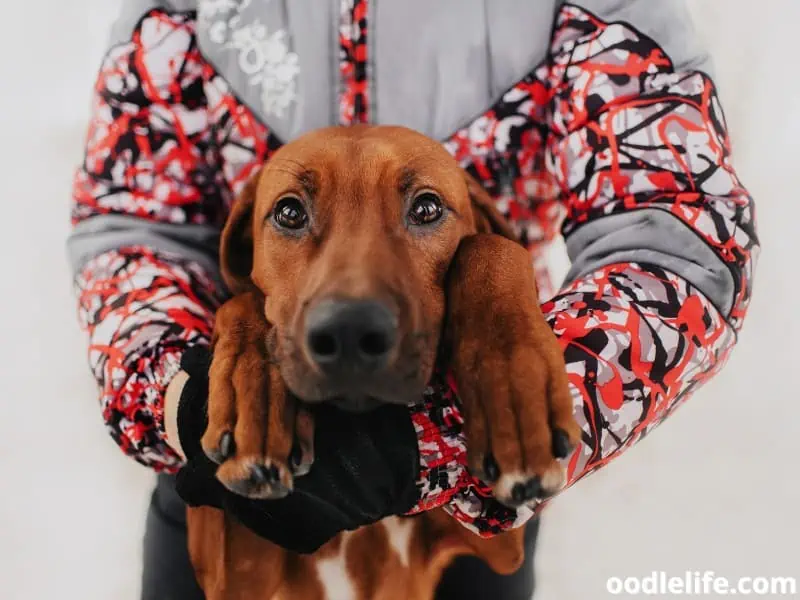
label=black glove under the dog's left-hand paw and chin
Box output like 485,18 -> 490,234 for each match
176,346 -> 419,554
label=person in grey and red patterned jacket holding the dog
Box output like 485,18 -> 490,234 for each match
69,0 -> 758,598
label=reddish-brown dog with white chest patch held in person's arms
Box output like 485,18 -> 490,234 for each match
188,126 -> 579,600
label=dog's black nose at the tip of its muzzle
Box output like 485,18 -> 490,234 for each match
306,300 -> 397,375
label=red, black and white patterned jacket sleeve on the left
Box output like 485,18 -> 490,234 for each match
69,3 -> 227,471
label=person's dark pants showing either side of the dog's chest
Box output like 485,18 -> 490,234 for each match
142,475 -> 539,600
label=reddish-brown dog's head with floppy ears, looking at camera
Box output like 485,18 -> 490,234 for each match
221,126 -> 510,410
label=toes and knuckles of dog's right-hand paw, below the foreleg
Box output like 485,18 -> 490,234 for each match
456,345 -> 580,508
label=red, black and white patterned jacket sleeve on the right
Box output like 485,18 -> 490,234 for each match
416,0 -> 758,535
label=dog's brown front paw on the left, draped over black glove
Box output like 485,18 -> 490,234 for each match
201,293 -> 313,499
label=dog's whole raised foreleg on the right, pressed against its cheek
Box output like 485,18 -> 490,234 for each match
445,234 -> 580,507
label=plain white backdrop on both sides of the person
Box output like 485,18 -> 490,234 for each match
0,0 -> 800,600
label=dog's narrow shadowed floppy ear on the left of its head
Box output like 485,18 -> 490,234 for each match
219,173 -> 259,295
